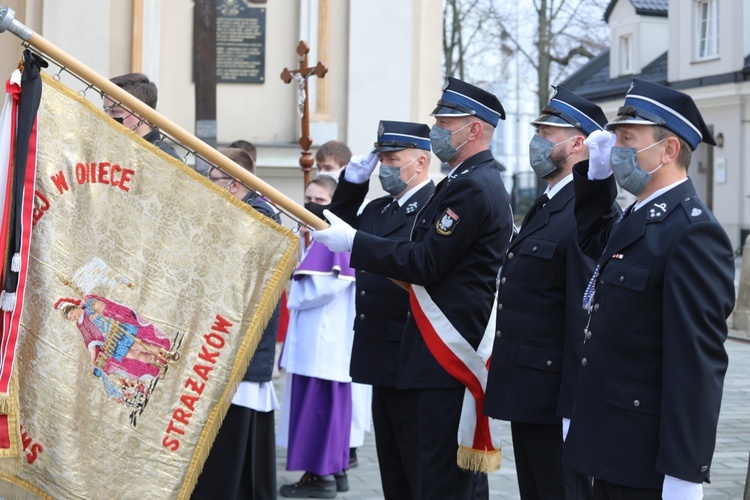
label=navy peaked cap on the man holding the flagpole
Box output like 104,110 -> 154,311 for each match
430,76 -> 505,127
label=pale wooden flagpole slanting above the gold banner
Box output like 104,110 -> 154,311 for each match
0,7 -> 328,229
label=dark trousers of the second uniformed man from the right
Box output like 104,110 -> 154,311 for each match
510,422 -> 565,500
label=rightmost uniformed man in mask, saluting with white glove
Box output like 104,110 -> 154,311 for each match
563,79 -> 735,500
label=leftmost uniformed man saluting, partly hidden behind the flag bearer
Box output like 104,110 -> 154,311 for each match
330,121 -> 435,499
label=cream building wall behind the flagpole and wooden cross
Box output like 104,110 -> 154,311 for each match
0,0 -> 443,223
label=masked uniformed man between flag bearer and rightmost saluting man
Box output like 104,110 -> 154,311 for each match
484,87 -> 617,500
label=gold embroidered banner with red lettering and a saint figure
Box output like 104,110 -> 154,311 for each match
0,76 -> 298,500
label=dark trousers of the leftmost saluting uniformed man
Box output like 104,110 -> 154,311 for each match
372,386 -> 420,500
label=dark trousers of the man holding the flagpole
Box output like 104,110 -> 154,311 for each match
414,387 -> 489,500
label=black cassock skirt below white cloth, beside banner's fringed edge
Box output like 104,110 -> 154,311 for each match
192,405 -> 276,500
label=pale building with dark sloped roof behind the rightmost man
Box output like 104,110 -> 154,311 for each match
562,0 -> 750,249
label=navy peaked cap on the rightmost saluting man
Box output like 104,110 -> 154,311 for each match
607,78 -> 716,151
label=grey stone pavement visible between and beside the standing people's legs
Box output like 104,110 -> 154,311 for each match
275,338 -> 750,500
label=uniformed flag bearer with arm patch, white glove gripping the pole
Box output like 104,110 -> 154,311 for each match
314,78 -> 513,500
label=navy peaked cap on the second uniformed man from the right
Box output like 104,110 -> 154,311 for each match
531,87 -> 607,135
